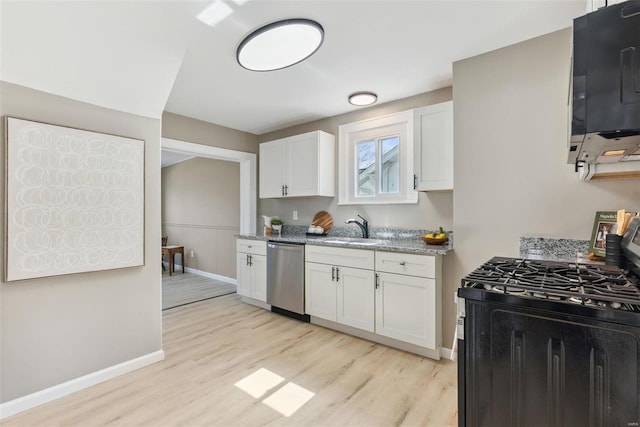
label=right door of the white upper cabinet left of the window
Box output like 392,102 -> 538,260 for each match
286,132 -> 318,197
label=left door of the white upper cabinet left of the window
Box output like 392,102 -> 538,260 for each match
260,139 -> 287,199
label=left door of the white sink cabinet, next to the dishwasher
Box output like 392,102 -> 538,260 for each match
304,262 -> 337,322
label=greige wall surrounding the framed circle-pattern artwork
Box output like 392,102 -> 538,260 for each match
0,82 -> 162,403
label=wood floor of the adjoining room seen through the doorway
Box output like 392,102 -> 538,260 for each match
162,272 -> 236,310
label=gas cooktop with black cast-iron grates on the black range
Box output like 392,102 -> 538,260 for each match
463,257 -> 640,312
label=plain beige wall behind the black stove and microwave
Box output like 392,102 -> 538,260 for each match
444,28 -> 640,336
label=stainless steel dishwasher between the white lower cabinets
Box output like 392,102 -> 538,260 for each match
267,242 -> 309,322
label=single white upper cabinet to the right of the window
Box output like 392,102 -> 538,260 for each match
413,101 -> 453,191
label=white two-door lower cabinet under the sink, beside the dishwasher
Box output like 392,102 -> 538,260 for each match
305,245 -> 375,332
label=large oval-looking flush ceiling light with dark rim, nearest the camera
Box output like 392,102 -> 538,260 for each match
236,19 -> 324,71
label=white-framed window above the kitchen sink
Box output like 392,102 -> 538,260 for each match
338,111 -> 418,205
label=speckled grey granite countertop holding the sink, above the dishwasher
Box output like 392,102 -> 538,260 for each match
236,233 -> 453,255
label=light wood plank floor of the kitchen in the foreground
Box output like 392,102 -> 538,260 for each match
2,294 -> 457,427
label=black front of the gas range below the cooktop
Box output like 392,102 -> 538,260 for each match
458,299 -> 640,426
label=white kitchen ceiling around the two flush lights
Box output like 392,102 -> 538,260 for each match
0,0 -> 586,134
